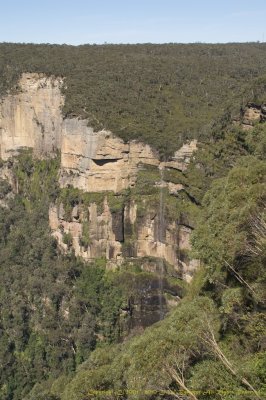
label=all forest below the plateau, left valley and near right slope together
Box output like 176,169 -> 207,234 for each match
0,114 -> 266,400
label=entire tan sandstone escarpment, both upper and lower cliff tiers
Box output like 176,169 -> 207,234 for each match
0,74 -> 200,280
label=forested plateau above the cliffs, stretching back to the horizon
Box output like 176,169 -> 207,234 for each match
0,43 -> 266,156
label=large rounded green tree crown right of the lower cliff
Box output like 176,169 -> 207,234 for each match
193,157 -> 266,267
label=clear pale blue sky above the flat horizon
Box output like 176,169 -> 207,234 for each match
0,0 -> 266,45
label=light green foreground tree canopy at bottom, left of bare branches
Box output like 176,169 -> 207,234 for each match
62,298 -> 220,400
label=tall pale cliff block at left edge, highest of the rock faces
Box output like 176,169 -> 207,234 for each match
0,74 -> 64,160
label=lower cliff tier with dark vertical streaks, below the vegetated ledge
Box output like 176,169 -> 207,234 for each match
49,198 -> 198,281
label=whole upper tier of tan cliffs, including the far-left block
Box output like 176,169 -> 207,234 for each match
0,74 -> 197,193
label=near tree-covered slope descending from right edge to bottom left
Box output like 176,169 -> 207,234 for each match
25,113 -> 266,400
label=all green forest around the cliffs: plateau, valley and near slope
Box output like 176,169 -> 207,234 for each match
0,44 -> 266,400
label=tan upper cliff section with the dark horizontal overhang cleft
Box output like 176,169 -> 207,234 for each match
60,119 -> 159,193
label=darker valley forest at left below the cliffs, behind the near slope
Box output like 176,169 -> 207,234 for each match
0,151 -> 181,400
